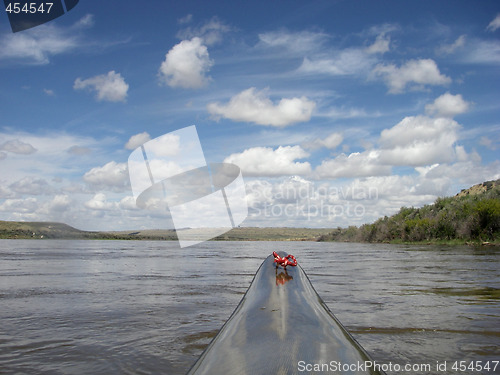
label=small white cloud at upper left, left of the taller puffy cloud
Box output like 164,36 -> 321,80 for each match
73,70 -> 129,102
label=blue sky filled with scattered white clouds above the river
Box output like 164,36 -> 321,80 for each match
0,0 -> 500,230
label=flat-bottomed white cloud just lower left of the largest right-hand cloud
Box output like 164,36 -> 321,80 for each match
315,150 -> 391,179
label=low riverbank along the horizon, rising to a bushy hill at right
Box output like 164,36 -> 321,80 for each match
0,180 -> 500,246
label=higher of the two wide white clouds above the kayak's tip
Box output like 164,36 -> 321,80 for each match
207,87 -> 316,127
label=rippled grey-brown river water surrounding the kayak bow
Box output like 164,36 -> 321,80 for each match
0,240 -> 500,375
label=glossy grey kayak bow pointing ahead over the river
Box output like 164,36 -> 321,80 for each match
188,253 -> 383,375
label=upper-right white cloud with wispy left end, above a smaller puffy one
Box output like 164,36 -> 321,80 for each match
373,59 -> 451,94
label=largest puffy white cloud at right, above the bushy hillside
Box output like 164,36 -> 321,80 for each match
379,116 -> 460,166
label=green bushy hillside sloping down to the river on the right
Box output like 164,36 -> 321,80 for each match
319,180 -> 500,245
